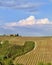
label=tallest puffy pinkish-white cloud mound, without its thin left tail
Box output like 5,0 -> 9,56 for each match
18,16 -> 35,26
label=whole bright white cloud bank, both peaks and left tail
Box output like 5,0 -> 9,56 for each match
4,16 -> 52,28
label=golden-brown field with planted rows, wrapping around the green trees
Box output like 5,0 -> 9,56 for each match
0,36 -> 52,65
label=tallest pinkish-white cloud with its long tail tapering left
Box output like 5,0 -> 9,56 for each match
4,16 -> 35,29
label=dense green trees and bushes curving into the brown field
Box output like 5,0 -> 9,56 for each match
0,40 -> 35,65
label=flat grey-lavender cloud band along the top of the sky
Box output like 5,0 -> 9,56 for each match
0,0 -> 45,9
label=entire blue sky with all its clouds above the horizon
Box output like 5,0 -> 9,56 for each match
0,0 -> 52,36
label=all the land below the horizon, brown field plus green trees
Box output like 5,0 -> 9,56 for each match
0,36 -> 52,65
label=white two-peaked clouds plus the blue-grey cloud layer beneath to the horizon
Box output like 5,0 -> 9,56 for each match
0,16 -> 52,36
